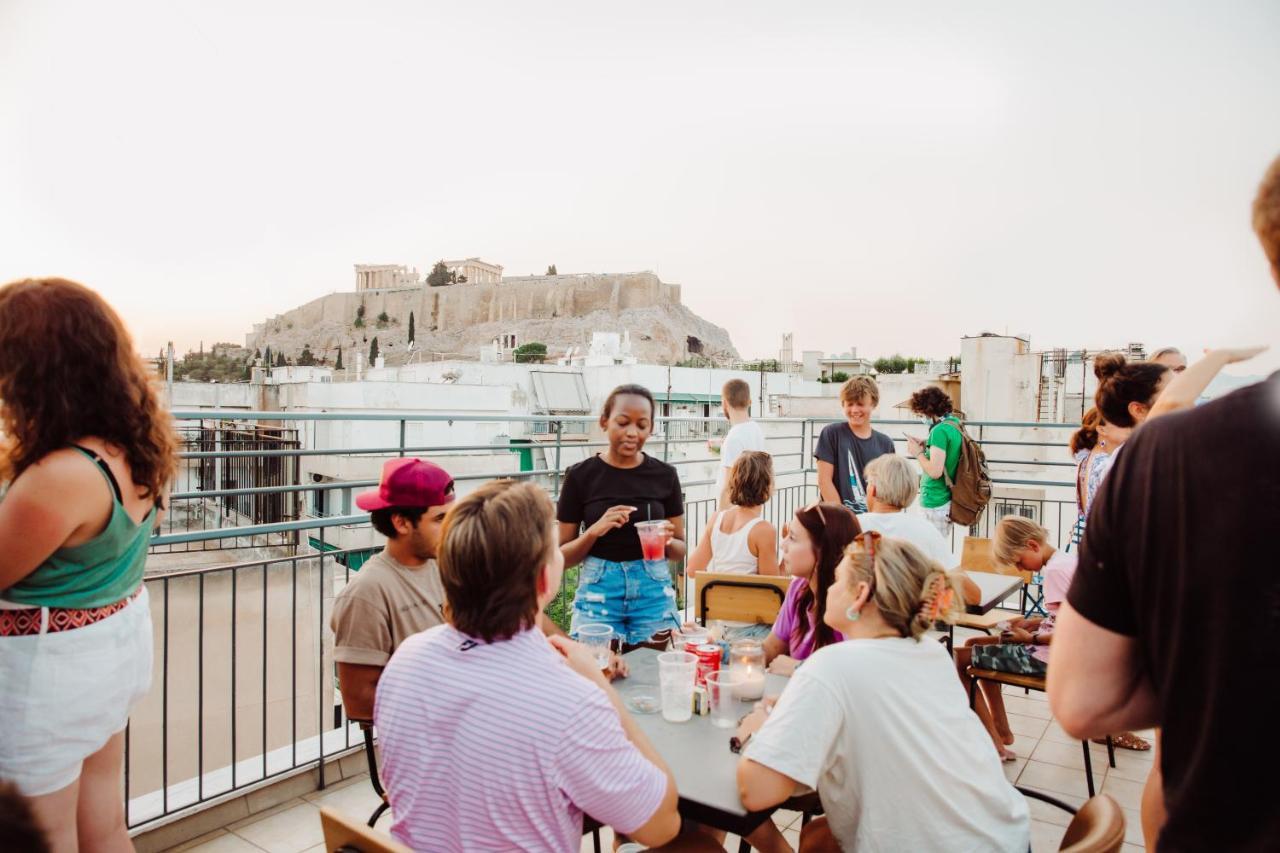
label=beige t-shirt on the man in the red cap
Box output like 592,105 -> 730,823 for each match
329,551 -> 444,666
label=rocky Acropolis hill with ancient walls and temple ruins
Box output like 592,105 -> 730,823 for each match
246,266 -> 737,366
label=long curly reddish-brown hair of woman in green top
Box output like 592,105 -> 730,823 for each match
0,278 -> 178,497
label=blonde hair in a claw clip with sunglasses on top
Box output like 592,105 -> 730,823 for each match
845,533 -> 964,640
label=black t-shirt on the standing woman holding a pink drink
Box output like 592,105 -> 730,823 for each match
556,453 -> 685,562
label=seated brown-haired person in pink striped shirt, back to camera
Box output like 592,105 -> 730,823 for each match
374,480 -> 696,850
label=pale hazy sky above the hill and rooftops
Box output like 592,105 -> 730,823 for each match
0,0 -> 1280,374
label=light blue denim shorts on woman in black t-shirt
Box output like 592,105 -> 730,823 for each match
570,557 -> 681,643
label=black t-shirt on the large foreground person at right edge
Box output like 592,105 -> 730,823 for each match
1068,373 -> 1280,852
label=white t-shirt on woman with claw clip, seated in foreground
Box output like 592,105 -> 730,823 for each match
746,638 -> 1030,853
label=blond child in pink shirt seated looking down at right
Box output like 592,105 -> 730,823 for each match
956,515 -> 1075,761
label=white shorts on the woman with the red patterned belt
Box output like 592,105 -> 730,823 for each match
0,587 -> 151,797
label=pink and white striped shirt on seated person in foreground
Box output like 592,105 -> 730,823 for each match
374,625 -> 667,850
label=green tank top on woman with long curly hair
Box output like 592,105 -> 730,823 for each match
0,446 -> 156,608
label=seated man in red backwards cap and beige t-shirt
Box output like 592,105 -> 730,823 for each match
329,459 -> 453,720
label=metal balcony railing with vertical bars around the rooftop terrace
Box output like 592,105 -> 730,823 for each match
125,411 -> 1075,831
